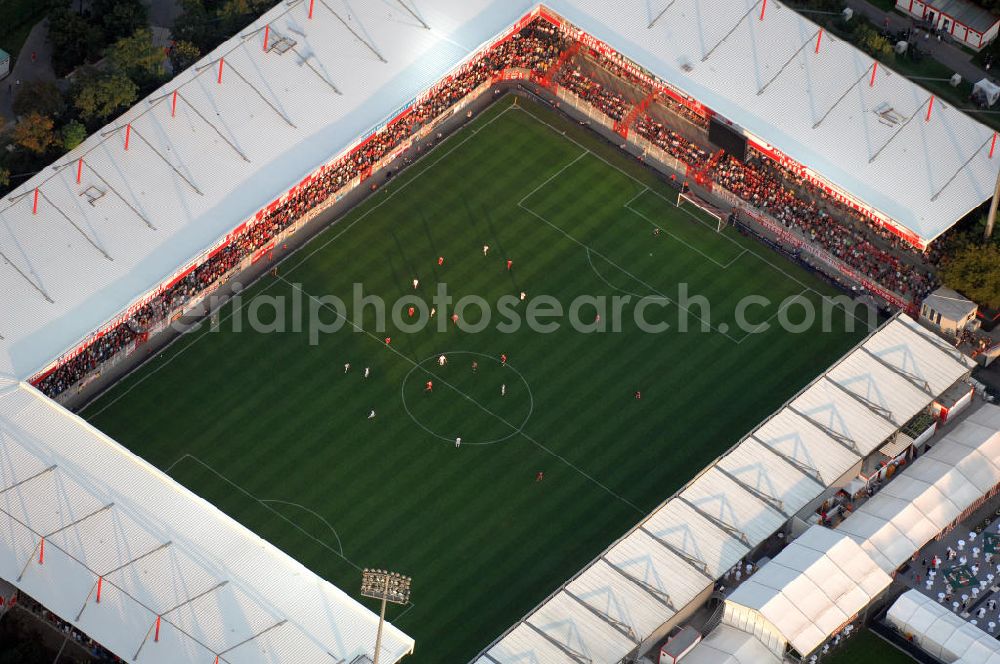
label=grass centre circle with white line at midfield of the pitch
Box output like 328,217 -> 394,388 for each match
400,350 -> 535,445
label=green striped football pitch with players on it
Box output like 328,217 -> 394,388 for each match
83,98 -> 868,664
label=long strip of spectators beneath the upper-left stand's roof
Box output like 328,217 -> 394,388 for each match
36,20 -> 568,397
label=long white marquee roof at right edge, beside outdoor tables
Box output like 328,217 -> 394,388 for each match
838,405 -> 1000,573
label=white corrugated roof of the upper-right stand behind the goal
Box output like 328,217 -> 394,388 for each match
545,0 -> 1000,242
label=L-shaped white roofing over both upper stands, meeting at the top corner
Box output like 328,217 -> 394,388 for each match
0,0 -> 1000,379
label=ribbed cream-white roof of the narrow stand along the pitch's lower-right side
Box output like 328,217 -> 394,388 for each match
476,316 -> 972,664
